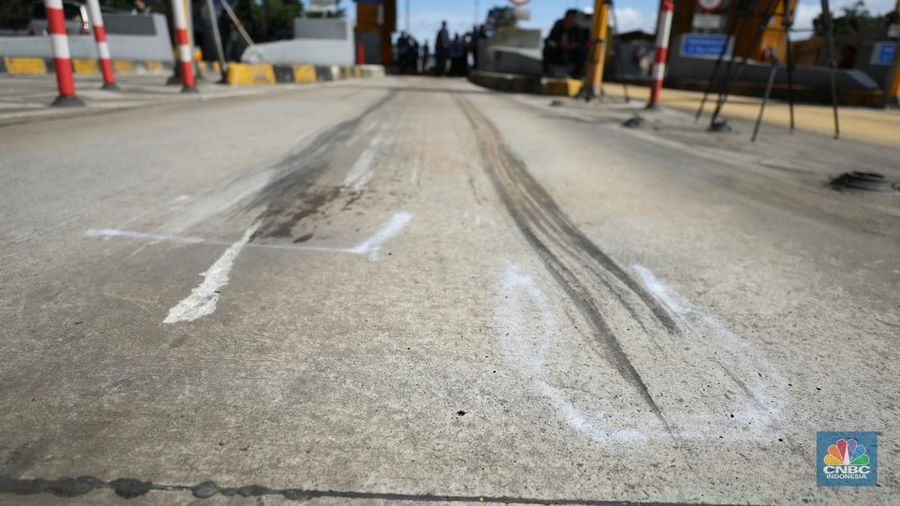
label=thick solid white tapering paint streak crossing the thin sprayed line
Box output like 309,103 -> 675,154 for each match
163,222 -> 259,323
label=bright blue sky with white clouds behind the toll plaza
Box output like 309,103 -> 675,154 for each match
343,0 -> 896,45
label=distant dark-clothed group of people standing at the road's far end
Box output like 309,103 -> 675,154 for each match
396,21 -> 485,76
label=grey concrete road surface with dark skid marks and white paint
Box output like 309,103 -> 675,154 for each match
0,78 -> 900,505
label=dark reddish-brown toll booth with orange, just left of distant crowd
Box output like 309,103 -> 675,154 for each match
355,0 -> 397,65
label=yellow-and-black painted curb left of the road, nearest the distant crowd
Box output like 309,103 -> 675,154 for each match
226,63 -> 385,86
